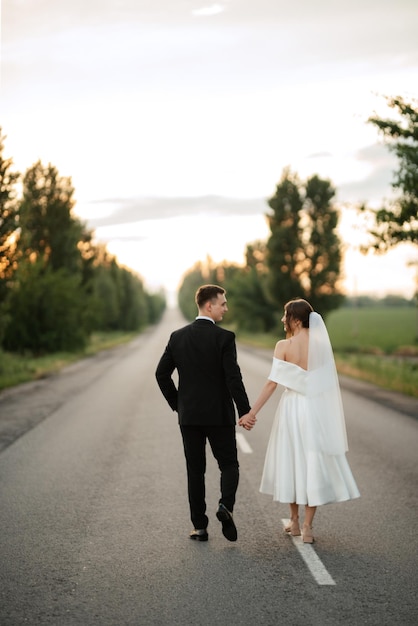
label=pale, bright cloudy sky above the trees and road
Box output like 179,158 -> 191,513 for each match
0,0 -> 418,296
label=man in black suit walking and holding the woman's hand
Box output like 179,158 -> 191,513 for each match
156,285 -> 250,541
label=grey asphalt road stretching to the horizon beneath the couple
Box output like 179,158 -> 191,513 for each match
0,311 -> 418,626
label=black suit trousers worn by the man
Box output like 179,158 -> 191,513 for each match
180,424 -> 239,528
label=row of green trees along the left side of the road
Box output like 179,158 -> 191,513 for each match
0,134 -> 166,355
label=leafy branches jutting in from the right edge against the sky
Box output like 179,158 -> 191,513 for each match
368,97 -> 418,252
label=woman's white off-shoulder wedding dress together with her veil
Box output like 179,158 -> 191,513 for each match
260,313 -> 360,506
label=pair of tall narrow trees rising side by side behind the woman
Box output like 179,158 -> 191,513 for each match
267,170 -> 343,316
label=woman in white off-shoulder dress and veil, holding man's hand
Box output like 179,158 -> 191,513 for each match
238,298 -> 360,543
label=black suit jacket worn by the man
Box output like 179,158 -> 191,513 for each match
155,319 -> 251,426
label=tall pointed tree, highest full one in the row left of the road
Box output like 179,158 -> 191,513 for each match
4,162 -> 92,353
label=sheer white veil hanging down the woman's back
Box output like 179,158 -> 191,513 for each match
307,313 -> 348,455
